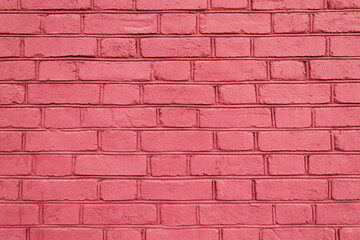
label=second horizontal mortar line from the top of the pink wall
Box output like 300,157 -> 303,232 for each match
4,31 -> 360,39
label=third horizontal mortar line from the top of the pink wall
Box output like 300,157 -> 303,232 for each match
0,56 -> 360,60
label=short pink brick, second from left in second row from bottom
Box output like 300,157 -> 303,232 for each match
43,204 -> 80,225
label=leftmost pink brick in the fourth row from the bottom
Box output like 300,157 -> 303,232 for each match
0,155 -> 32,176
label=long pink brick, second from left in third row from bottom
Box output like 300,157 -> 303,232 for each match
22,180 -> 97,201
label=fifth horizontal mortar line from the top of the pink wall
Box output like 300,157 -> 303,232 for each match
0,103 -> 360,107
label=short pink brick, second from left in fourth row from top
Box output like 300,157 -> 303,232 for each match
39,61 -> 77,80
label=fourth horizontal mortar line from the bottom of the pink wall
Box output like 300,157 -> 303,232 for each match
0,149 -> 360,156
